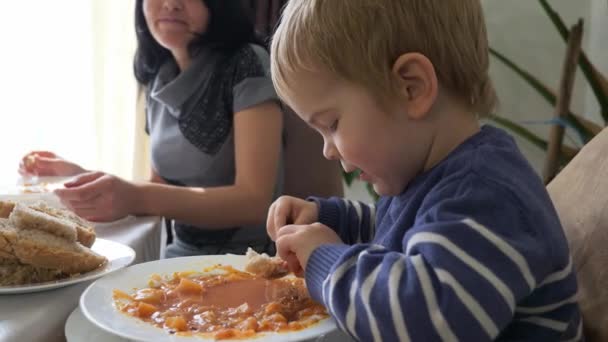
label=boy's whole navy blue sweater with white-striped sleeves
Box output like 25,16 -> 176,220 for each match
306,126 -> 582,341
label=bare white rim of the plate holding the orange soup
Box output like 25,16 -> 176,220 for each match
80,254 -> 336,342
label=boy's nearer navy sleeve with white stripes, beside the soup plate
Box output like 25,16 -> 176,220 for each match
306,218 -> 576,341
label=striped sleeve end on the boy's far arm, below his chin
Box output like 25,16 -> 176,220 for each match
309,197 -> 376,244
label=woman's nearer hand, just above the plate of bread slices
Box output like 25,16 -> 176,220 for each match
55,172 -> 138,222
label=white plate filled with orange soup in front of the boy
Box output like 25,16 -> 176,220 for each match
80,250 -> 336,342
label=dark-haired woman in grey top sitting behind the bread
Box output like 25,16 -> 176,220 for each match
20,0 -> 282,257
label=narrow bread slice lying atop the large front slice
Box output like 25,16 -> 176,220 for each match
9,203 -> 78,242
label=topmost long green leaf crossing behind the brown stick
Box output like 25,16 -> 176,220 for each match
538,0 -> 608,124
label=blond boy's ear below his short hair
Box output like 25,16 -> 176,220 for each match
392,53 -> 439,120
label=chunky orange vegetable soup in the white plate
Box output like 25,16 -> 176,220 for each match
114,265 -> 328,339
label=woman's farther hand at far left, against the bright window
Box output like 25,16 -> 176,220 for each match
19,151 -> 86,176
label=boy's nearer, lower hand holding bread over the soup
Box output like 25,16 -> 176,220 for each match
274,222 -> 344,276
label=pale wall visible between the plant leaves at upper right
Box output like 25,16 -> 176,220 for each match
346,0 -> 608,200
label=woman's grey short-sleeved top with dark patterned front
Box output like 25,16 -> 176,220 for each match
146,45 -> 282,254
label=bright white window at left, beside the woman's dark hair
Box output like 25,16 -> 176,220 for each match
0,0 -> 136,184
